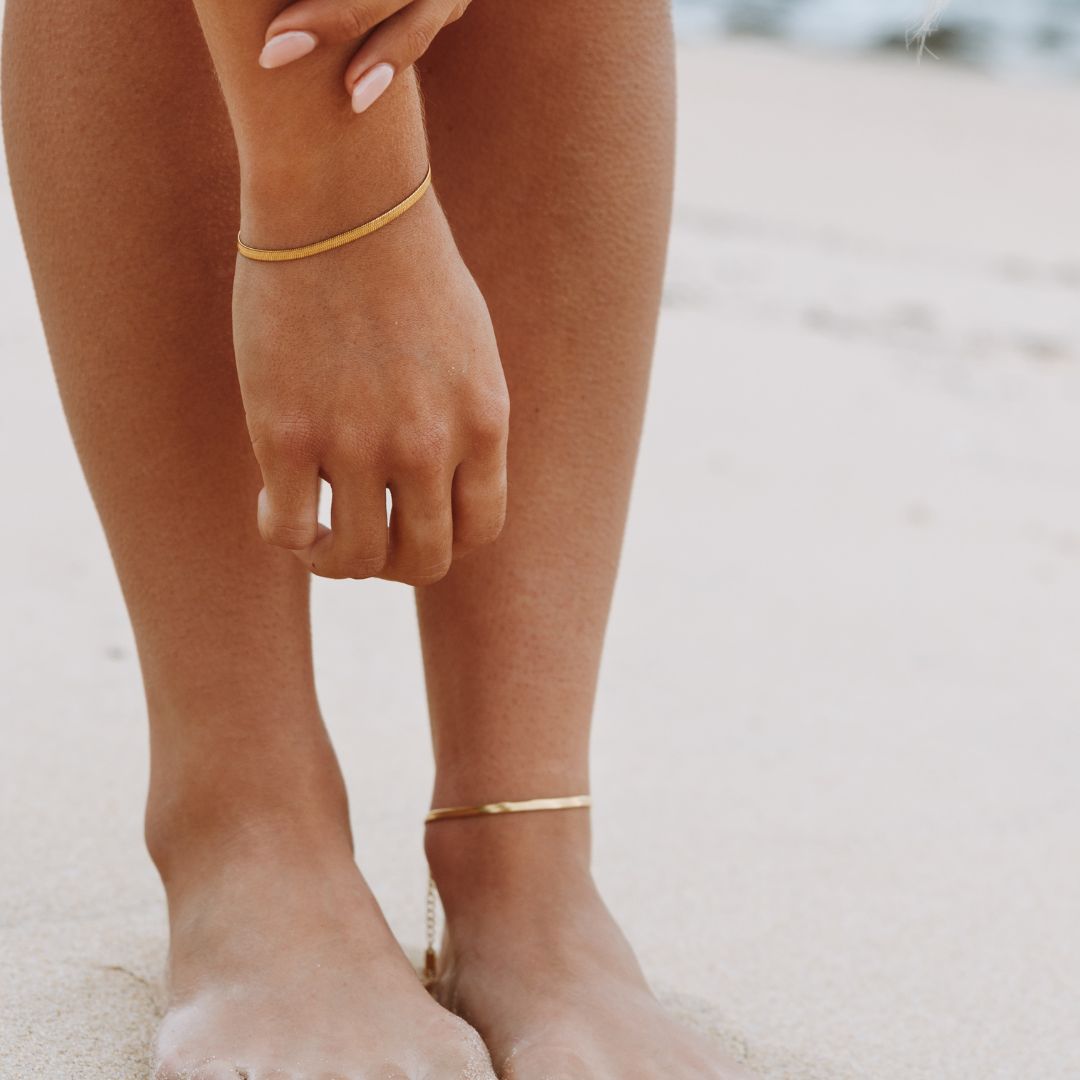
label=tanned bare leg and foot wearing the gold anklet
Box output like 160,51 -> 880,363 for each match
418,0 -> 737,1080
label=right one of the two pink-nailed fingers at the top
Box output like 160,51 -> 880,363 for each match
345,0 -> 459,112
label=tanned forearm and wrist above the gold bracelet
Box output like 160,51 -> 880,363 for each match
194,0 -> 427,246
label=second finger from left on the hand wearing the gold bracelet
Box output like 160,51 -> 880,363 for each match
297,482 -> 387,578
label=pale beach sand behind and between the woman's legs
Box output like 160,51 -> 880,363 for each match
0,39 -> 1080,1080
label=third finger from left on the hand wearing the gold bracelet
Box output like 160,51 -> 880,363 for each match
379,476 -> 454,585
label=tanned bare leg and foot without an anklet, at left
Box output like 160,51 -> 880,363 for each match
2,0 -> 490,1080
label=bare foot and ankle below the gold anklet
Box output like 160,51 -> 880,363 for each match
427,811 -> 751,1080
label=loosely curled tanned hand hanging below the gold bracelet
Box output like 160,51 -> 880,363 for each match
233,192 -> 509,585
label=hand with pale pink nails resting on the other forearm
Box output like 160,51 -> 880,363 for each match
259,0 -> 469,112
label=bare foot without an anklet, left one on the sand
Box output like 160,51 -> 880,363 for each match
147,794 -> 494,1080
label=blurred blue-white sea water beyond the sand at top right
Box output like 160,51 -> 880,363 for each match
675,0 -> 1080,78
